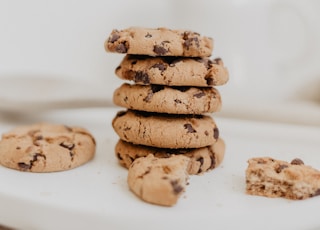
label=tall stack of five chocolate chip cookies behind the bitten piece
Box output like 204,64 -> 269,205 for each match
105,28 -> 229,206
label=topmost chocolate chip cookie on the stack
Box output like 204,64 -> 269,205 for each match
104,27 -> 213,57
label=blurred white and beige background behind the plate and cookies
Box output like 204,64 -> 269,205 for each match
0,0 -> 320,125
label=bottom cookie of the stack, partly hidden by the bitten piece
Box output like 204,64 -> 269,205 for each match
115,138 -> 225,175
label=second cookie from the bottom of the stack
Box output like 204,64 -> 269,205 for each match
112,110 -> 219,148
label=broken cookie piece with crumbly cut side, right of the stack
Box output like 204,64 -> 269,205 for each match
246,157 -> 320,200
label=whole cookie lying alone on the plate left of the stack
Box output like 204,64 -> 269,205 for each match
0,123 -> 96,172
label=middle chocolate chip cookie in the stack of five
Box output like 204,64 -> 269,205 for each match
113,83 -> 221,114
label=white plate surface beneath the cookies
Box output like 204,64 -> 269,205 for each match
0,109 -> 320,230
